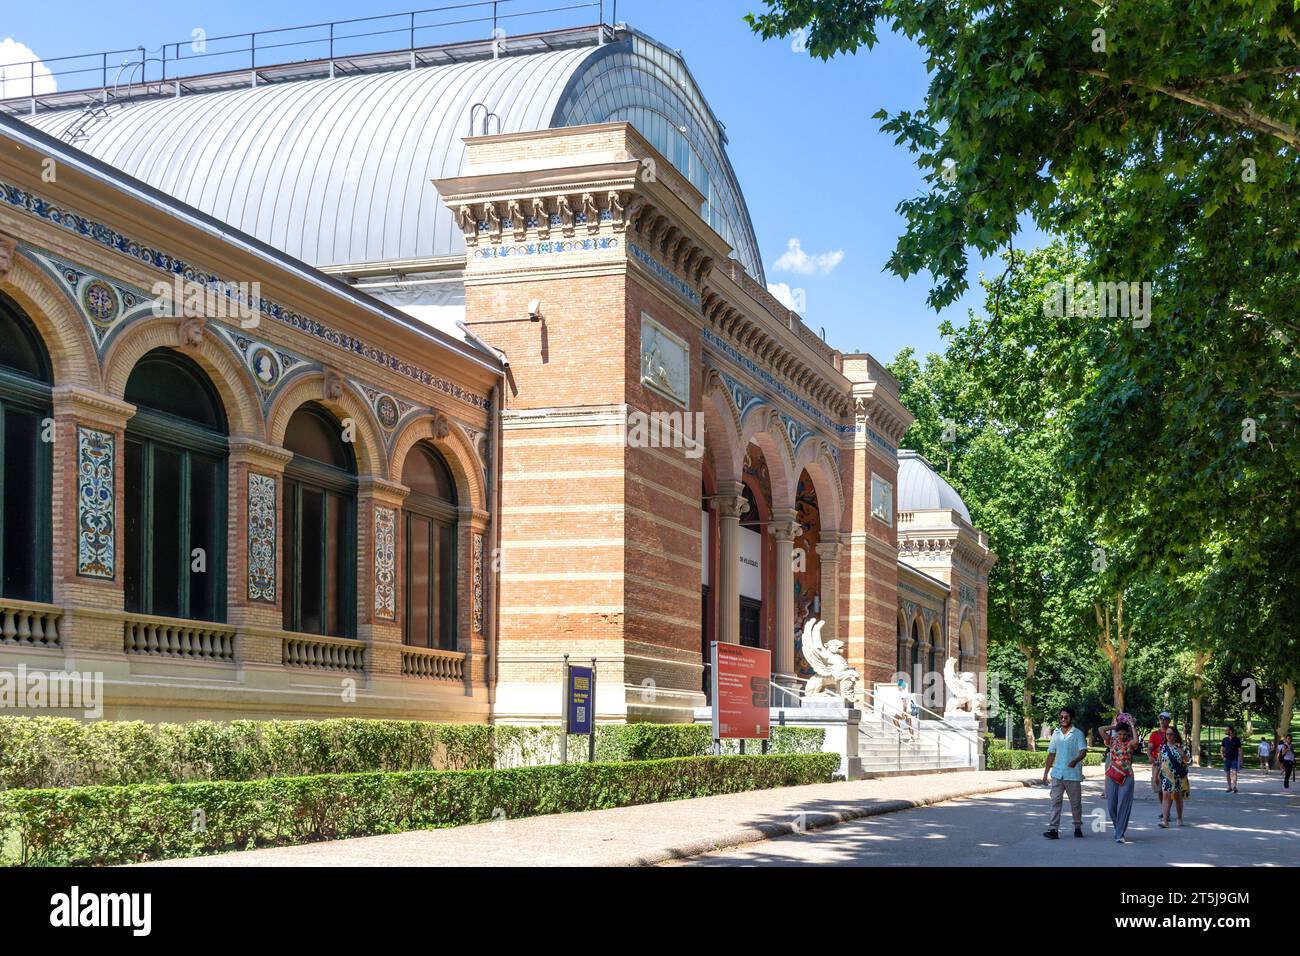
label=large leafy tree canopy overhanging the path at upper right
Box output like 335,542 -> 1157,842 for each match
749,0 -> 1300,724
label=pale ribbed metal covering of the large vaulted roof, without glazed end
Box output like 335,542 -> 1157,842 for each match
27,47 -> 593,265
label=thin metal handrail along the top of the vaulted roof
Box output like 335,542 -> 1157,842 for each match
0,0 -> 618,100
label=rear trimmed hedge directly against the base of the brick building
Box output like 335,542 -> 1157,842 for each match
0,717 -> 823,790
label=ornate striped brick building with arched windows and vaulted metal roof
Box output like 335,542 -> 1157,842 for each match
0,18 -> 996,722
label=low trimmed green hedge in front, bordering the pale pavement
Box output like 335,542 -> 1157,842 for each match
0,753 -> 840,866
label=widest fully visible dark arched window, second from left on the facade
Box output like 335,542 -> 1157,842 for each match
124,349 -> 228,620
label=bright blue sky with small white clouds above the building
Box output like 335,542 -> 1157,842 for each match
0,0 -> 1030,360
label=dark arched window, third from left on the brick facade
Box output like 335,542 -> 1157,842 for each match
283,403 -> 356,637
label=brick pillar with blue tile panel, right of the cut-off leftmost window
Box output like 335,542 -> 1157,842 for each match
51,385 -> 135,654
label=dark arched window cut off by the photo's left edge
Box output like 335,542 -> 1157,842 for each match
0,293 -> 53,601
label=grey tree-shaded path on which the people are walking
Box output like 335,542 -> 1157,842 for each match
686,769 -> 1300,866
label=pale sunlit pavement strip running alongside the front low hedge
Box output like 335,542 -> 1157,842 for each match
148,767 -> 1100,866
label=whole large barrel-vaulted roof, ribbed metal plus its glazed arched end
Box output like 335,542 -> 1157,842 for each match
30,31 -> 763,281
